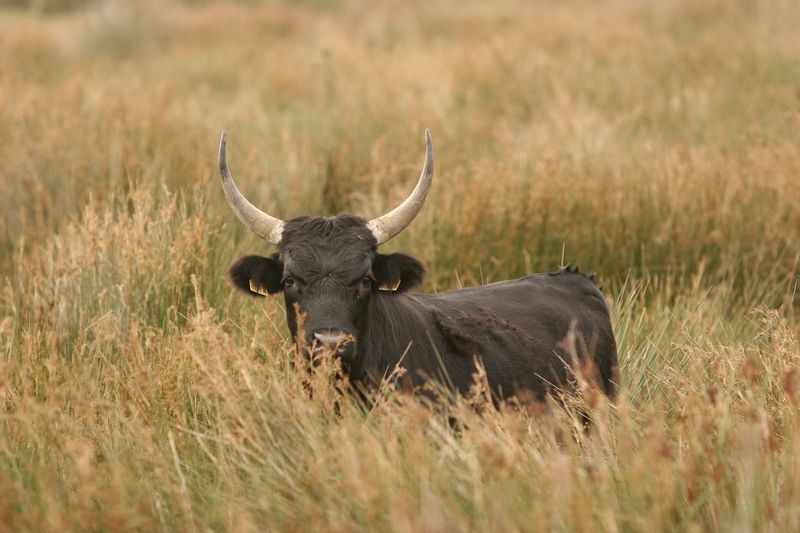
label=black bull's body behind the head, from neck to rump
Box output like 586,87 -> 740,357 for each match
347,269 -> 617,399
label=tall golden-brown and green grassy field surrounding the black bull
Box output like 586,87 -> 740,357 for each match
0,0 -> 800,532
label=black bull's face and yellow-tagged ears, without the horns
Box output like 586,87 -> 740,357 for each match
229,214 -> 425,365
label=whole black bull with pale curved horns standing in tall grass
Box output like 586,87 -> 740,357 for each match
220,131 -> 617,399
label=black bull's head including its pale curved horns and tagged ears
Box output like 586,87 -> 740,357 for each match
219,130 -> 433,365
